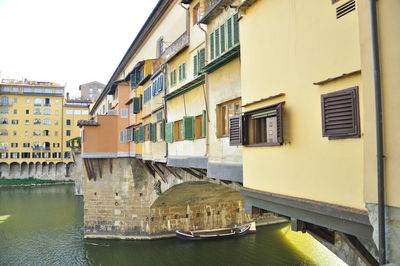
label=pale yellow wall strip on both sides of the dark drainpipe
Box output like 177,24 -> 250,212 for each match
357,0 -> 400,207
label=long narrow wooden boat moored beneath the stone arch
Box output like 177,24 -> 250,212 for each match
175,221 -> 252,240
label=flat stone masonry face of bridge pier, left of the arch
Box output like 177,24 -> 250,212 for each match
84,158 -> 157,238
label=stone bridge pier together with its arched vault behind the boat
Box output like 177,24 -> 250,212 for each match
84,158 -> 251,239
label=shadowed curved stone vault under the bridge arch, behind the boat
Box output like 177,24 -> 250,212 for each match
150,181 -> 251,234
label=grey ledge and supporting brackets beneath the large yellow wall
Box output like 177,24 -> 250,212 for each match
241,188 -> 378,265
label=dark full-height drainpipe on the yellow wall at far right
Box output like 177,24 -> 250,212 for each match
369,0 -> 386,265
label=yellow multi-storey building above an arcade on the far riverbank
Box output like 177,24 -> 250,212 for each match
0,80 -> 89,178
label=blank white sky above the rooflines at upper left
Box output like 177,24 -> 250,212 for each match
0,0 -> 157,96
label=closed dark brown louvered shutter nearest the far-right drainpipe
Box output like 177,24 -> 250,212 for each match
321,87 -> 360,139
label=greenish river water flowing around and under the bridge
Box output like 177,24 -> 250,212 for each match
0,185 -> 345,266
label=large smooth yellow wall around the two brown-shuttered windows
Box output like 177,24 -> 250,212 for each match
240,0 -> 365,209
